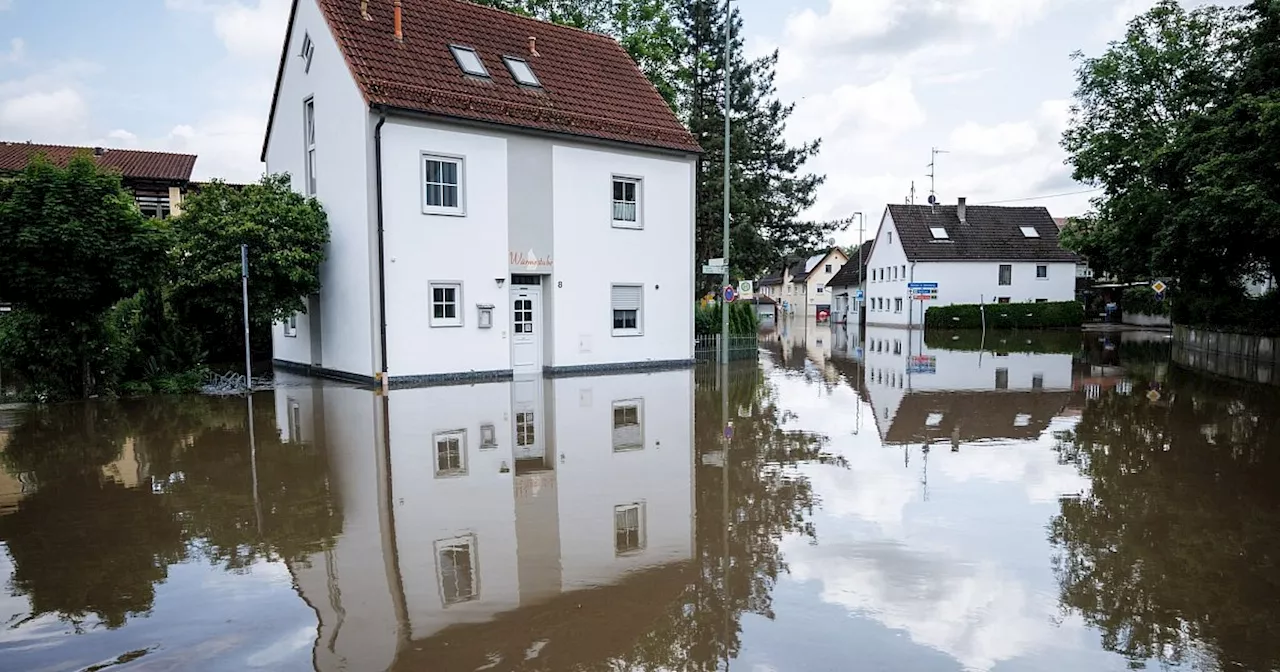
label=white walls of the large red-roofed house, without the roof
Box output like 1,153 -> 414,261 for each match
264,0 -> 696,380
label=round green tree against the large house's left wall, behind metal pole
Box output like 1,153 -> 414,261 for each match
172,174 -> 329,360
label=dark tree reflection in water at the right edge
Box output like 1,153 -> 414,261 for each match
1050,370 -> 1280,669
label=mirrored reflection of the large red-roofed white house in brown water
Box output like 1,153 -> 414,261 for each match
276,370 -> 692,671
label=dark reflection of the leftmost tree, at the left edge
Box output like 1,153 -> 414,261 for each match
0,404 -> 184,628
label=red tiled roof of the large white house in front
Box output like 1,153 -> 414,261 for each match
264,0 -> 701,156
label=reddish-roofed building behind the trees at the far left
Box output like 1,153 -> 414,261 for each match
0,141 -> 196,219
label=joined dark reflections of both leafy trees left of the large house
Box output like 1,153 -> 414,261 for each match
0,389 -> 342,627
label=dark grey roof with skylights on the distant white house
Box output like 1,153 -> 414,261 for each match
888,205 -> 1078,262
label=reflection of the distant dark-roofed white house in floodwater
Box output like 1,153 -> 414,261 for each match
864,326 -> 1073,444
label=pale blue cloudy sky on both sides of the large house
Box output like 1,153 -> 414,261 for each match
0,0 -> 1231,244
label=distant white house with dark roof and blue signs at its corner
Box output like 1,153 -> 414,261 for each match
867,198 -> 1078,326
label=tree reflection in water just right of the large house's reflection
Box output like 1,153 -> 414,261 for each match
591,362 -> 844,671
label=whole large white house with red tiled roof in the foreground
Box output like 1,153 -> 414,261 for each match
262,0 -> 699,384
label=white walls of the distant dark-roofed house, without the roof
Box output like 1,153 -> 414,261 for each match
867,210 -> 1075,326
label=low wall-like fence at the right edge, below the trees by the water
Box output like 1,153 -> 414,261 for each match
1174,326 -> 1280,384
